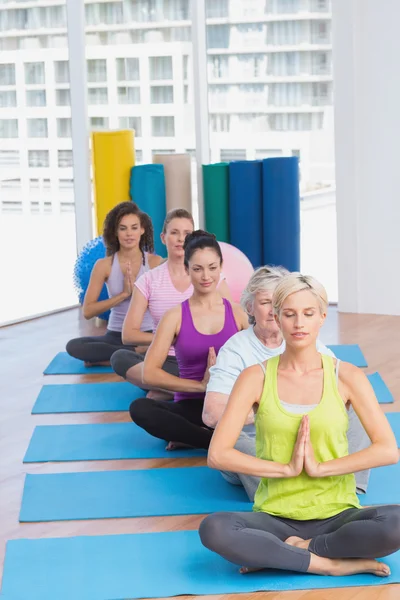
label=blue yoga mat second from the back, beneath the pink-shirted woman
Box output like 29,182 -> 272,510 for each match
32,382 -> 146,415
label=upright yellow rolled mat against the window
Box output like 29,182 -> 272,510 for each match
92,129 -> 135,235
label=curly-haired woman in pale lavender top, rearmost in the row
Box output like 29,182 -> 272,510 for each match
66,202 -> 162,366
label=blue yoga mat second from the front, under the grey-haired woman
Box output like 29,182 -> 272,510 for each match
20,464 -> 400,522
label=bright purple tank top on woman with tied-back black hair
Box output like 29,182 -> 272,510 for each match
174,298 -> 238,402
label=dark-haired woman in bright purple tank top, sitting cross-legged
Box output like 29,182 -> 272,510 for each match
129,230 -> 248,450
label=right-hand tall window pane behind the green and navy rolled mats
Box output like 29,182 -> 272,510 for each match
208,0 -> 337,302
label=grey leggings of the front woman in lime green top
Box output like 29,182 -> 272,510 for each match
199,505 -> 400,572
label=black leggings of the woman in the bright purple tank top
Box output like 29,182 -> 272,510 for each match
129,398 -> 213,449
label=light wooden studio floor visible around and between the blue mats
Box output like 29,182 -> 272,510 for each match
0,308 -> 400,600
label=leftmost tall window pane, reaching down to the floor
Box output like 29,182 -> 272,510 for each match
0,0 -> 77,324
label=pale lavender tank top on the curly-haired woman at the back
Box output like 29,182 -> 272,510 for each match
106,252 -> 153,331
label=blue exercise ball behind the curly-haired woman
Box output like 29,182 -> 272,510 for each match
74,236 -> 110,321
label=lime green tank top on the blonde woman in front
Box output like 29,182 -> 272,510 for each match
253,354 -> 361,521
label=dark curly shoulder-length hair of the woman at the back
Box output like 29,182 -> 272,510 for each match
103,201 -> 154,264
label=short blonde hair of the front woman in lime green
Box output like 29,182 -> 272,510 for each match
272,272 -> 328,316
